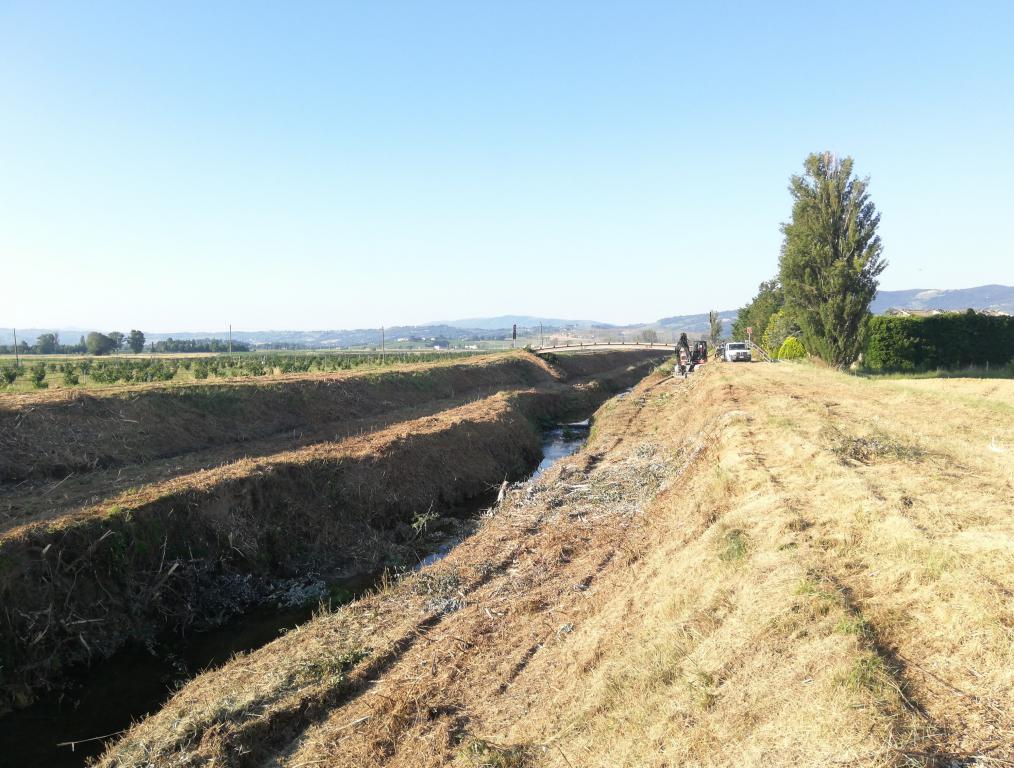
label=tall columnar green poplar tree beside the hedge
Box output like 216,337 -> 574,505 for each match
779,152 -> 887,368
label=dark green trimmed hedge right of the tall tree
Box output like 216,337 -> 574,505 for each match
864,309 -> 1014,370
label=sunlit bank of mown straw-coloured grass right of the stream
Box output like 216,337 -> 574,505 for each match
101,364 -> 1014,768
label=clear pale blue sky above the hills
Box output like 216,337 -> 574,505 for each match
0,0 -> 1014,331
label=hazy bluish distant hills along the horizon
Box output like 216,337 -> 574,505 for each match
0,285 -> 1014,348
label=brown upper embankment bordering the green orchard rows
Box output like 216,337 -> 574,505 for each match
0,352 -> 555,483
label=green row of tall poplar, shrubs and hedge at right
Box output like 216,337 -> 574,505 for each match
731,153 -> 1014,371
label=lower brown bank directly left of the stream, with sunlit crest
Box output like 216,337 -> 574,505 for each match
0,357 -> 665,708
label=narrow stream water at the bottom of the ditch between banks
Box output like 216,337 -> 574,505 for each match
0,419 -> 589,768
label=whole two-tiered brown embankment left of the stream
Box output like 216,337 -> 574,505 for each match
0,352 -> 657,711
